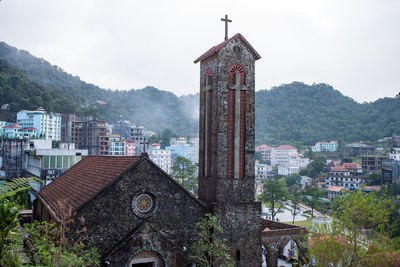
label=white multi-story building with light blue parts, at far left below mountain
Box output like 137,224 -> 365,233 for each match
17,109 -> 61,141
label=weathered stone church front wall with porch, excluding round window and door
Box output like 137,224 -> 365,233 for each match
35,157 -> 208,266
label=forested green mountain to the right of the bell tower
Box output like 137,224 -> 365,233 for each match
256,82 -> 400,145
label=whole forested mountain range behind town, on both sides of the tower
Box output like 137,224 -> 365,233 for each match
0,42 -> 400,145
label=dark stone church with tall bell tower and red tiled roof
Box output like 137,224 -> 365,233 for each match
34,29 -> 304,267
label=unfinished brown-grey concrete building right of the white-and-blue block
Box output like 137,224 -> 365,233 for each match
61,114 -> 107,156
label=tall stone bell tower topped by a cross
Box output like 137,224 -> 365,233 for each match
194,27 -> 261,266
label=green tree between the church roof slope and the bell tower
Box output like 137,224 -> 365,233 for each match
172,156 -> 198,196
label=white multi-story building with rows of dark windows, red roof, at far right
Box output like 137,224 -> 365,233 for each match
325,164 -> 365,189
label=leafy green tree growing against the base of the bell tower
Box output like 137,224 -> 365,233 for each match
189,214 -> 234,267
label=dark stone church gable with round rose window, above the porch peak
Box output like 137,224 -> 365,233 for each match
70,158 -> 207,260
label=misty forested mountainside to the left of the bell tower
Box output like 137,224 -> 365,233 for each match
0,42 -> 198,135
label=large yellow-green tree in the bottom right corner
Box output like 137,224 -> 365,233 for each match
309,191 -> 398,266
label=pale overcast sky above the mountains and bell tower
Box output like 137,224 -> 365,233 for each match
0,0 -> 400,102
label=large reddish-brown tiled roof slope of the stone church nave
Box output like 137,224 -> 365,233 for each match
38,156 -> 139,218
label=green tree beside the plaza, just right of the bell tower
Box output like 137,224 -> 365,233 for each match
261,178 -> 288,220
